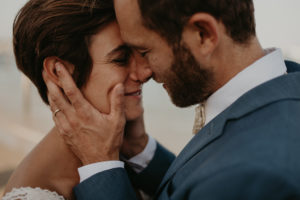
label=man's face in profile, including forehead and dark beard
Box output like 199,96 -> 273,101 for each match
114,0 -> 213,107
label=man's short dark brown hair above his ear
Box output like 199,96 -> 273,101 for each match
138,0 -> 256,44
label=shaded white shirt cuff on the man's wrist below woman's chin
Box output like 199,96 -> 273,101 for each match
127,135 -> 157,173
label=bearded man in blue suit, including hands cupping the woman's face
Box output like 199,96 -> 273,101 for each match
45,0 -> 300,200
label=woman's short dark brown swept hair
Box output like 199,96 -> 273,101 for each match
13,0 -> 115,104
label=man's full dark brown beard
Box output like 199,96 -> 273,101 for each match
164,42 -> 214,108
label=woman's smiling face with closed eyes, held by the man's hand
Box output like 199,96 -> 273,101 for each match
82,22 -> 143,120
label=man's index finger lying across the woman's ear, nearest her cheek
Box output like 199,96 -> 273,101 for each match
55,62 -> 89,110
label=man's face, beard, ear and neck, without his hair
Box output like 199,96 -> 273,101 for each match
114,0 -> 263,107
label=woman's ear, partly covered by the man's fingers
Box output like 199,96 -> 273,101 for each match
43,56 -> 74,87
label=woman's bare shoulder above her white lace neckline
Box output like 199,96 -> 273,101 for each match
5,129 -> 81,198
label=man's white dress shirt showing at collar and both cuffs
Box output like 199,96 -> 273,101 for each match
78,49 -> 287,182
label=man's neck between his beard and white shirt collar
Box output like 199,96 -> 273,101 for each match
214,37 -> 265,91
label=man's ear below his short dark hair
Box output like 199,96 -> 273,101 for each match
183,13 -> 223,56
